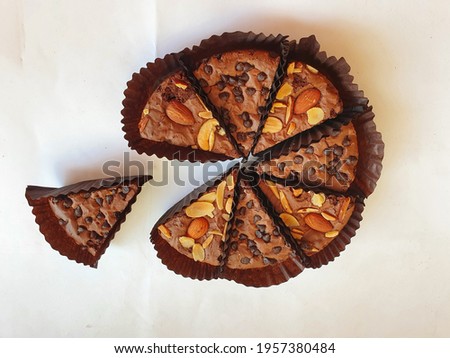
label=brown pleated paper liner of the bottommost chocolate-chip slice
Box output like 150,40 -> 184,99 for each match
219,173 -> 308,287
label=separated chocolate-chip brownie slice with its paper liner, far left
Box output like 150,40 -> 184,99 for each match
25,176 -> 151,267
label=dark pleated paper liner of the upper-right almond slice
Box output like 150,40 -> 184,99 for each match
253,35 -> 368,155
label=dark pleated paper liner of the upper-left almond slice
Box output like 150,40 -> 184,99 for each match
121,54 -> 237,162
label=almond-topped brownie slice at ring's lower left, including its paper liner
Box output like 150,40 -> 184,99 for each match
151,168 -> 238,280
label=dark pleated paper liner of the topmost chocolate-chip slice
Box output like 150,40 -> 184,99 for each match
180,31 -> 289,154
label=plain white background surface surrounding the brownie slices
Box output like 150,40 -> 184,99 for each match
0,0 -> 450,337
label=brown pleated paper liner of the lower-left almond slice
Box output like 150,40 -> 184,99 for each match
150,165 -> 238,280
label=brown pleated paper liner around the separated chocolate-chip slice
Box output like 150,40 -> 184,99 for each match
25,176 -> 151,268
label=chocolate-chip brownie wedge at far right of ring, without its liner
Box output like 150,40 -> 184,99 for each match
256,123 -> 359,192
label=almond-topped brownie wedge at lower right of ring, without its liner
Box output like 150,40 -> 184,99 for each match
259,179 -> 356,256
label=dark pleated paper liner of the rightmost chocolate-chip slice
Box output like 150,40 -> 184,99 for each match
251,107 -> 384,198
